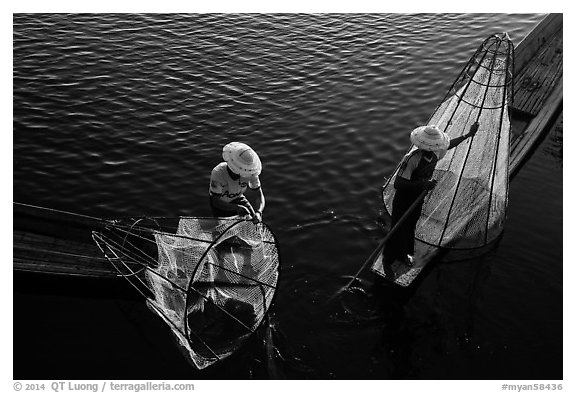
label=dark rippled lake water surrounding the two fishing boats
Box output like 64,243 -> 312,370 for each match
13,14 -> 562,379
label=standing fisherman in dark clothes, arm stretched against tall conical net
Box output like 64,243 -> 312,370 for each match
384,122 -> 479,275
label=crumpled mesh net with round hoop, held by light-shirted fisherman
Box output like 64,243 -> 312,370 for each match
93,218 -> 279,369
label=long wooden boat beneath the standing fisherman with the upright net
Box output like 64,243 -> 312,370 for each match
372,14 -> 563,286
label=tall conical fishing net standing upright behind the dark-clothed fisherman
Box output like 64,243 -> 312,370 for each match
383,34 -> 514,249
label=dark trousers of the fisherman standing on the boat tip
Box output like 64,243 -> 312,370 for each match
384,190 -> 424,264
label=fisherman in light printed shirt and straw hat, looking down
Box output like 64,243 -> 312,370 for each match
209,142 -> 265,223
